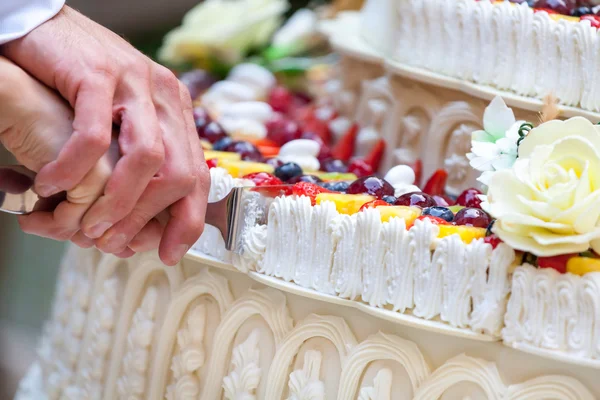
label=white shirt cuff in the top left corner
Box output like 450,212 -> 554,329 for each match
0,0 -> 65,44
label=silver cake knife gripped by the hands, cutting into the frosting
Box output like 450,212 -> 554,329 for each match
0,165 -> 288,254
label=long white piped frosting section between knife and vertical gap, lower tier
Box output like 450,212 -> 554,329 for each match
244,196 -> 514,336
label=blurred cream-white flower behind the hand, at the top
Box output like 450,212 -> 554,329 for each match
159,0 -> 289,64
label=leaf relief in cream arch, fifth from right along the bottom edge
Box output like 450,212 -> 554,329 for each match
117,286 -> 158,400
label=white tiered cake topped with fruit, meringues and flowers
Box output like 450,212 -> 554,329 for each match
19,0 -> 600,400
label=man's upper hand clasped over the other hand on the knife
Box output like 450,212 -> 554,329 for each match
4,7 -> 210,265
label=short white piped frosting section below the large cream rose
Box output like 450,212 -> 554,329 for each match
502,265 -> 600,359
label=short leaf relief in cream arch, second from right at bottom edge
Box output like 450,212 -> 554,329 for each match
287,350 -> 325,400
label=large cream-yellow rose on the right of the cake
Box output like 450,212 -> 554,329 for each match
483,117 -> 600,256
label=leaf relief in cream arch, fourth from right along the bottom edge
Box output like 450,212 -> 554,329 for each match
165,304 -> 207,400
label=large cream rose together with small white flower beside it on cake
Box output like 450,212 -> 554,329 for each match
468,97 -> 600,275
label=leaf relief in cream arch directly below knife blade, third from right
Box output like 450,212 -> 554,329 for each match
223,329 -> 261,400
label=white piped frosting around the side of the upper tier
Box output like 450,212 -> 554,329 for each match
361,0 -> 600,111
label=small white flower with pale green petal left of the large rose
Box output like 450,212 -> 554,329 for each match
467,96 -> 524,186
